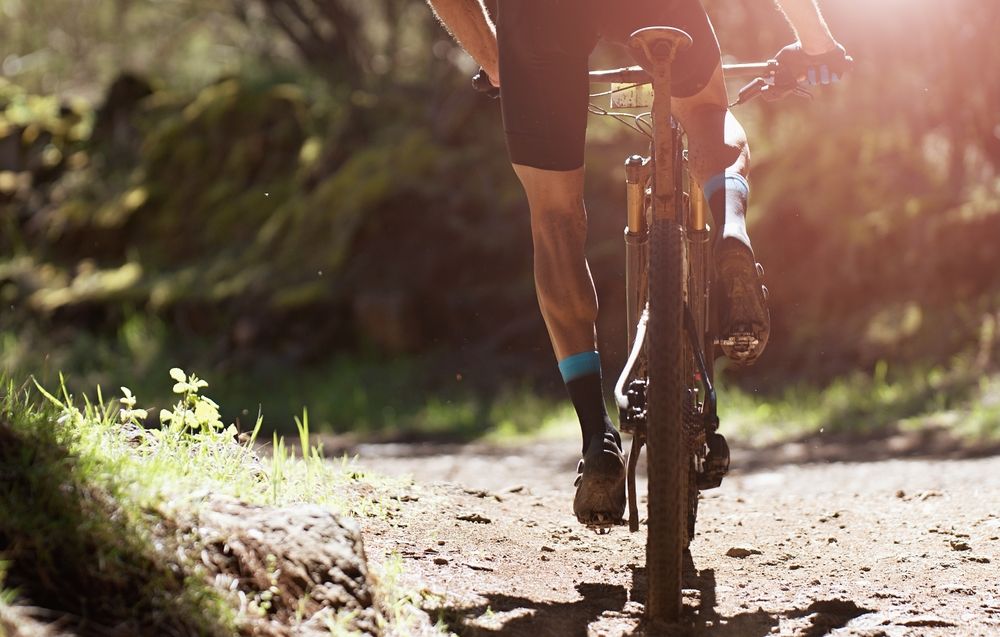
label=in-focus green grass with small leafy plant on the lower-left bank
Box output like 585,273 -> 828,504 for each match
0,369 -> 446,635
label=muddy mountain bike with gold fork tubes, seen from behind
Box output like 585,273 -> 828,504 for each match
473,27 -> 798,621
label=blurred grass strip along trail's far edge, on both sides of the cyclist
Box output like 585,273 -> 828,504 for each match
7,304 -> 1000,452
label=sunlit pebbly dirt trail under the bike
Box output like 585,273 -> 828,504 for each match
355,439 -> 1000,637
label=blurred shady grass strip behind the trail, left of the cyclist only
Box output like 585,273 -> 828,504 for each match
0,313 -> 575,441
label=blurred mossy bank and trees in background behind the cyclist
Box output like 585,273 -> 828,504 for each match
0,0 -> 1000,438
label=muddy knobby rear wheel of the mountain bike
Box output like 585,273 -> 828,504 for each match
646,220 -> 691,621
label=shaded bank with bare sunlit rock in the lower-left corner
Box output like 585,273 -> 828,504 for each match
0,404 -> 391,637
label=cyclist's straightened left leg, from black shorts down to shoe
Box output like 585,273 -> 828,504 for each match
497,0 -> 625,524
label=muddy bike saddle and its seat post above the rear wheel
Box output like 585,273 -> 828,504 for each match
629,27 -> 692,222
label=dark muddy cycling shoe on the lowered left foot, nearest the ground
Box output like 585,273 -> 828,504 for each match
573,433 -> 625,529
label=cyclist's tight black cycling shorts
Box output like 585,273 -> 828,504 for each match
497,0 -> 721,170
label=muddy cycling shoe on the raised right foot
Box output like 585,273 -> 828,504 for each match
715,239 -> 771,365
